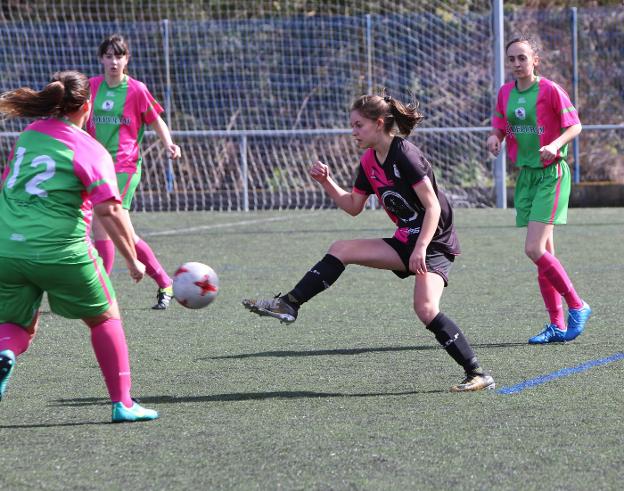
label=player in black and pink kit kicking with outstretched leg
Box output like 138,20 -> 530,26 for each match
243,95 -> 495,392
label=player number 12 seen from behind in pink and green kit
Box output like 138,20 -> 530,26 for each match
0,71 -> 158,422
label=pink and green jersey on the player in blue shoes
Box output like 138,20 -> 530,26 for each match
492,77 -> 580,168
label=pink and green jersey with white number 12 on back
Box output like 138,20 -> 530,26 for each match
0,118 -> 121,263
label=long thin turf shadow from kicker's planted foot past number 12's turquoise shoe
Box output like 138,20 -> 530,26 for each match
48,389 -> 449,408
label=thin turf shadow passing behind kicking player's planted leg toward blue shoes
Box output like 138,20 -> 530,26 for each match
207,342 -> 528,361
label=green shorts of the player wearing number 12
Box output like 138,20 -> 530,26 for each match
0,256 -> 115,326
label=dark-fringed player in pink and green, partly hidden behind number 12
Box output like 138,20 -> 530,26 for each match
87,34 -> 180,310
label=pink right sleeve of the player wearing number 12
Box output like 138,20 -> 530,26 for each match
74,137 -> 121,205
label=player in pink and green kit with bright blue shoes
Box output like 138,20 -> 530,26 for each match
487,36 -> 591,344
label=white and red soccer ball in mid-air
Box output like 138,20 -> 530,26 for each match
173,262 -> 219,309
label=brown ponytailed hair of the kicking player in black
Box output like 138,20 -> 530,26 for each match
351,95 -> 424,136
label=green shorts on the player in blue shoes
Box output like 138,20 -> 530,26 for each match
514,160 -> 570,227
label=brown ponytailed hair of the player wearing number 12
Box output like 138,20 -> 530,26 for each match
0,70 -> 91,118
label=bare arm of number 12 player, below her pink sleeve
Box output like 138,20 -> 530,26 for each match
94,200 -> 145,282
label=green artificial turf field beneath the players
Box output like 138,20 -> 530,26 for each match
0,208 -> 624,490
